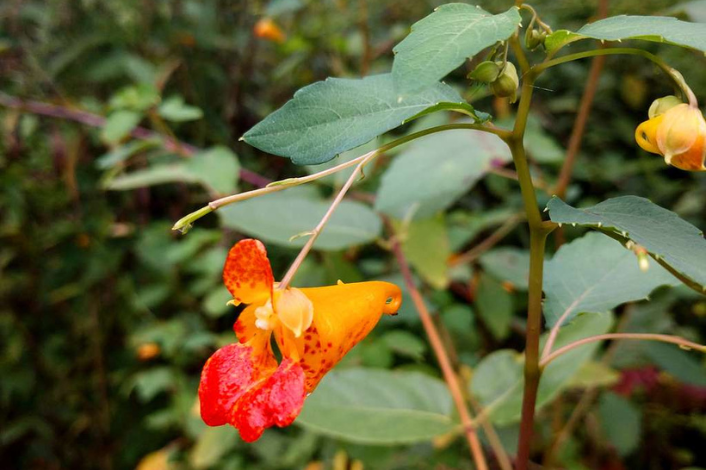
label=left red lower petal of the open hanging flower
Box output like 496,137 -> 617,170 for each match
199,344 -> 276,426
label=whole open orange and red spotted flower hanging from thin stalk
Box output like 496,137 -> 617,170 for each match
199,240 -> 402,442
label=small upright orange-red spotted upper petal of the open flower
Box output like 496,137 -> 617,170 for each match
223,239 -> 274,304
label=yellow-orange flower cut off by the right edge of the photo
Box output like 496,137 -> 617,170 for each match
635,97 -> 706,171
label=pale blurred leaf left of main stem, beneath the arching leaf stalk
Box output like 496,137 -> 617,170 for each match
375,129 -> 512,220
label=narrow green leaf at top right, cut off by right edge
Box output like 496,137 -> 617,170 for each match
545,15 -> 706,51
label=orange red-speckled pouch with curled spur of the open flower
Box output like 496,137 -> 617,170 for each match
296,281 -> 402,392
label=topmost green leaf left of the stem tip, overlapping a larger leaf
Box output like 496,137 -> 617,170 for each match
392,3 -> 521,96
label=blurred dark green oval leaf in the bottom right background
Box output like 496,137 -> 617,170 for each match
598,392 -> 642,457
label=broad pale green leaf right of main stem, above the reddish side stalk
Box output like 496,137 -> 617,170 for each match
544,233 -> 679,326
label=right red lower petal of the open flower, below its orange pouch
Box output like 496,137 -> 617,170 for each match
230,358 -> 305,442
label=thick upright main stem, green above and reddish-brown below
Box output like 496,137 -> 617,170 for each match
506,71 -> 556,470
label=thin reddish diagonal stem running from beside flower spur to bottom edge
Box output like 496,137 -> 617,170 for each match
384,236 -> 488,470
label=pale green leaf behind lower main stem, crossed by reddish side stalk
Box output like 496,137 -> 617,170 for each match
471,313 -> 613,425
